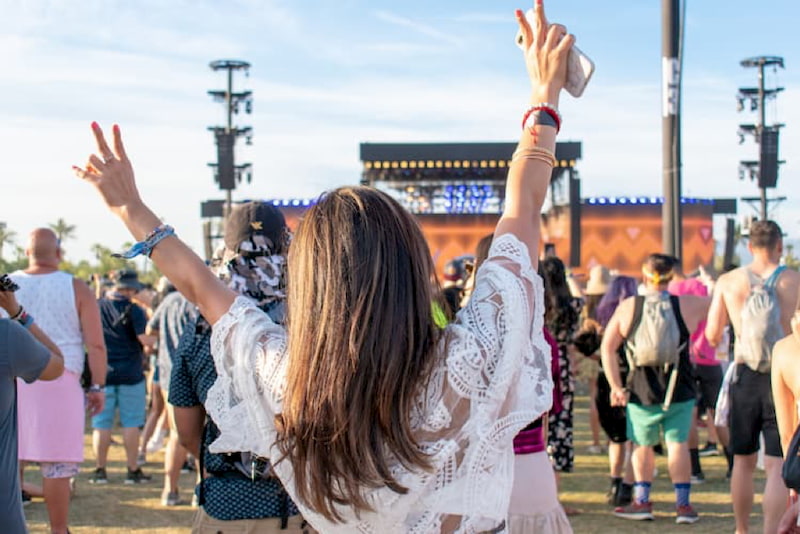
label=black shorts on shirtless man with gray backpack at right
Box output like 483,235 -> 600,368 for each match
729,364 -> 783,458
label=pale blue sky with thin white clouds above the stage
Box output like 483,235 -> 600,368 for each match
0,0 -> 800,260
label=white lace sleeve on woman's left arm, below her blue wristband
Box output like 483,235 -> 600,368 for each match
205,297 -> 286,458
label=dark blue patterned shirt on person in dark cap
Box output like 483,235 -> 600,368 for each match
169,317 -> 300,521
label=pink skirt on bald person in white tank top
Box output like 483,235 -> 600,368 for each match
17,371 -> 86,463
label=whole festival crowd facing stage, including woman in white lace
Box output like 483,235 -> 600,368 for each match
0,1 -> 800,534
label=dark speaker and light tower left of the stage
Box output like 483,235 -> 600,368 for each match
208,59 -> 253,217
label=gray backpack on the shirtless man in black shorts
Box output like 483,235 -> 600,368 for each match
734,265 -> 785,373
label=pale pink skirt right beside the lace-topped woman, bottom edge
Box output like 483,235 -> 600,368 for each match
508,452 -> 572,534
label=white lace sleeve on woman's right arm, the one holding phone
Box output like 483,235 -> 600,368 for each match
447,234 -> 552,422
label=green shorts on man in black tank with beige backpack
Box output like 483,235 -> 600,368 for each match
627,399 -> 694,447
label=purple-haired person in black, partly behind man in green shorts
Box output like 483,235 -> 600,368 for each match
595,276 -> 637,507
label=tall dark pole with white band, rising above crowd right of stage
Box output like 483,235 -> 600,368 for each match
661,0 -> 683,259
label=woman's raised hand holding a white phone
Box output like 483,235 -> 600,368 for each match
516,0 -> 575,105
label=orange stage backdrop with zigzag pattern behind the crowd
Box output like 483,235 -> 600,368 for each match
281,204 -> 714,277
